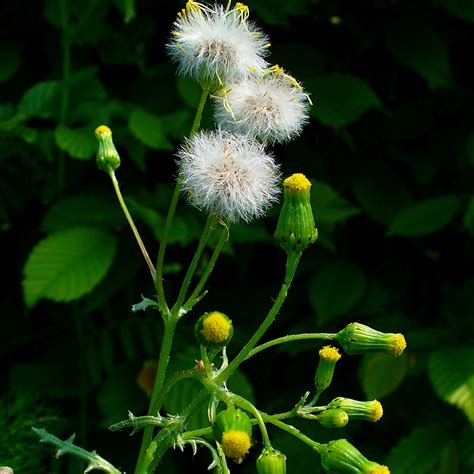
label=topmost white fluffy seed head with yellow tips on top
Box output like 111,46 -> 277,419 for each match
167,2 -> 269,87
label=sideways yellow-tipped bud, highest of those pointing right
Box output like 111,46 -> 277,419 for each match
336,323 -> 407,356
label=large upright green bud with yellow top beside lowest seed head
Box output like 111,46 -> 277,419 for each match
274,173 -> 318,253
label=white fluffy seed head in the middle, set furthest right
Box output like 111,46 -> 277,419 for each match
215,68 -> 310,143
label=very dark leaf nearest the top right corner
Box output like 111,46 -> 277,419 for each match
387,18 -> 452,88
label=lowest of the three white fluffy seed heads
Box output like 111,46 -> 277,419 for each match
178,130 -> 280,222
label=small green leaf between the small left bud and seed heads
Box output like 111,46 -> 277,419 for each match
128,107 -> 173,150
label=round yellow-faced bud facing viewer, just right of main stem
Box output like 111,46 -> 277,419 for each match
194,311 -> 234,349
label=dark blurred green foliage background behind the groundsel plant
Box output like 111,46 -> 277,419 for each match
0,0 -> 474,474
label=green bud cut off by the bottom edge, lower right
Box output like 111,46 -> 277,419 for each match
319,439 -> 390,474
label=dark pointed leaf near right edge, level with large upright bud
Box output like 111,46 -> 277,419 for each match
388,196 -> 462,237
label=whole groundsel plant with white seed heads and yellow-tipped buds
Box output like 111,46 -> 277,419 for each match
35,1 -> 406,474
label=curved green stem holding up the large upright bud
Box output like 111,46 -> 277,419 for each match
215,252 -> 301,385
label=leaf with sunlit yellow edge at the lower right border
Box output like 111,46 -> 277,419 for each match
428,347 -> 474,424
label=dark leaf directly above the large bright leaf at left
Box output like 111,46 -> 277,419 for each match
41,193 -> 125,233
